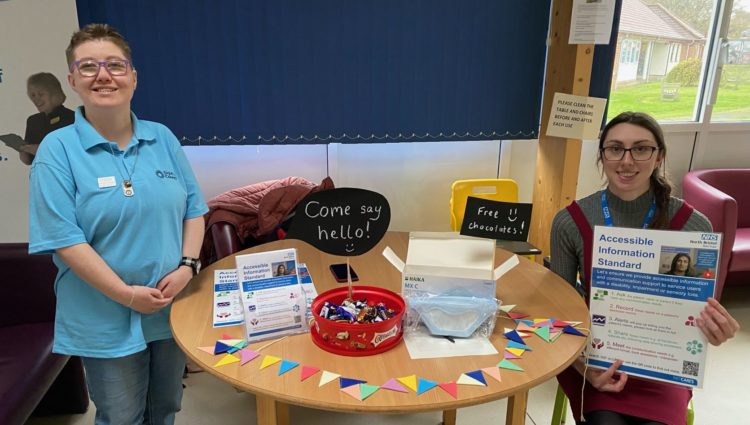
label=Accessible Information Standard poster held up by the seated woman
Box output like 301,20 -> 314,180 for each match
588,226 -> 721,388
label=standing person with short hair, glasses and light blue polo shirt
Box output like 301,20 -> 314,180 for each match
29,24 -> 208,424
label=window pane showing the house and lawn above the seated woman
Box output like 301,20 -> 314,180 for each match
607,0 -> 716,121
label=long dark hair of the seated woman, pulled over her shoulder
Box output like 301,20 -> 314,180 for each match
598,112 -> 672,229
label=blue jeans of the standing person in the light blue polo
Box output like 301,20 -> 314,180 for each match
82,339 -> 185,425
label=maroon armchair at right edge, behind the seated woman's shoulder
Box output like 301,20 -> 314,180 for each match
682,168 -> 750,296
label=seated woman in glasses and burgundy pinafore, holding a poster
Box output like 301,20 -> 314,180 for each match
550,112 -> 739,425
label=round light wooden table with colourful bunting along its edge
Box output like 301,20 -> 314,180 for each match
170,232 -> 589,425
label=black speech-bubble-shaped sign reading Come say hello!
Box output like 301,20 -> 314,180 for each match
287,187 -> 391,256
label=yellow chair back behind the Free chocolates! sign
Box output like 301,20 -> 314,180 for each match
450,179 -> 518,232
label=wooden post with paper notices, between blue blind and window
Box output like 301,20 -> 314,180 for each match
529,0 -> 594,262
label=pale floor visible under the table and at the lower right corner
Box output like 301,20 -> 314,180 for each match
26,286 -> 750,425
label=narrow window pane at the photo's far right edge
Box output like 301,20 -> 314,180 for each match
711,0 -> 750,121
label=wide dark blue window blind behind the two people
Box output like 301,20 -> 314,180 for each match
77,0 -> 550,145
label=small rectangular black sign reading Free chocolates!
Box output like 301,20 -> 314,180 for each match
461,196 -> 531,241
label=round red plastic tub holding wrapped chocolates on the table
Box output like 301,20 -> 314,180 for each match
310,286 -> 406,356
